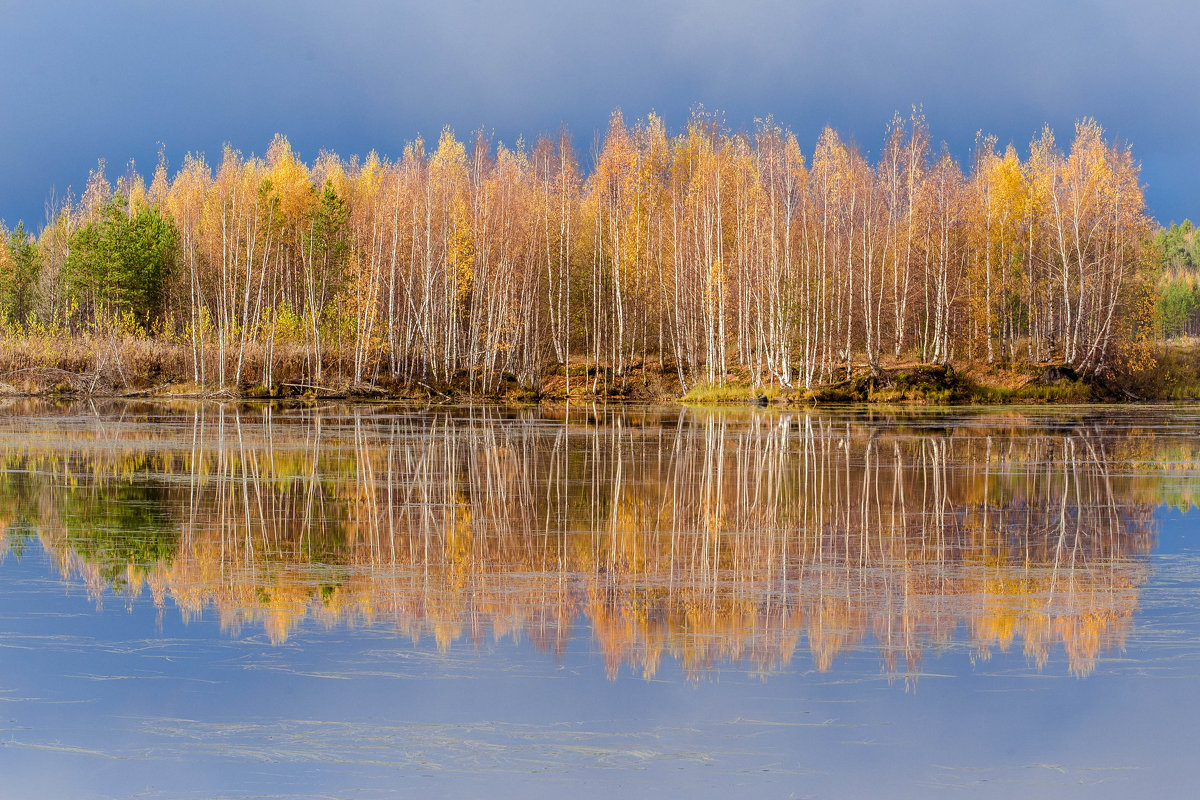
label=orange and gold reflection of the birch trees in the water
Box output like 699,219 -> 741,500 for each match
0,405 -> 1192,676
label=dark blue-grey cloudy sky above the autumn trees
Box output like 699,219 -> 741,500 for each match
0,0 -> 1200,228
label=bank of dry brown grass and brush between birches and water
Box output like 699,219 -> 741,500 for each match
0,337 -> 1200,407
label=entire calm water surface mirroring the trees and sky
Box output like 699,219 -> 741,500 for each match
0,403 -> 1200,799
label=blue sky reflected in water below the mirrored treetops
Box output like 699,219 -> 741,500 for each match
0,410 -> 1200,798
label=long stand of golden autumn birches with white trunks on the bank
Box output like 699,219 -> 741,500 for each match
0,112 -> 1158,392
